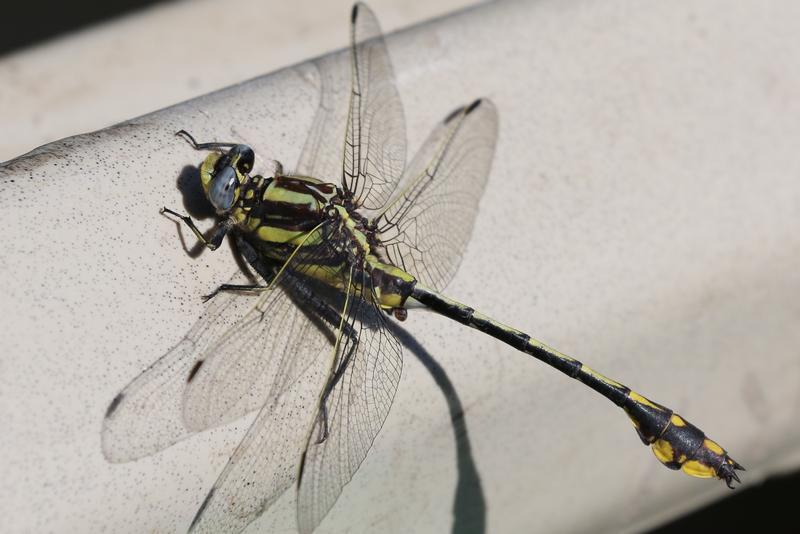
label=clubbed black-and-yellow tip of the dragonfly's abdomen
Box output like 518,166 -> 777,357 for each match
625,392 -> 744,488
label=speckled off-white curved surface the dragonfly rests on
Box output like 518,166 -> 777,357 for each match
0,0 -> 800,533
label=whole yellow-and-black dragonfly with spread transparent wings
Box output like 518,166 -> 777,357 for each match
102,4 -> 744,533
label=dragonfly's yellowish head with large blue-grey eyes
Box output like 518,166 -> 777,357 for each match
200,145 -> 255,214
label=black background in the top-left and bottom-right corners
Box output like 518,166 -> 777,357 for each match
0,0 -> 800,534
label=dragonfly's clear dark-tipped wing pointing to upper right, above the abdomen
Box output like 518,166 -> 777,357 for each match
378,98 -> 497,291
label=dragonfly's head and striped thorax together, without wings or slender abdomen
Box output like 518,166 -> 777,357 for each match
191,138 -> 416,320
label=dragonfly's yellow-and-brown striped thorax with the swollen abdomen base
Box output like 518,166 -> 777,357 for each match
223,175 -> 416,311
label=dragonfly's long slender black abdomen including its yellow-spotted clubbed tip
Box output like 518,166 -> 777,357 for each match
411,284 -> 744,488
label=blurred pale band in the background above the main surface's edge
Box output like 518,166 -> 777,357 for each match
0,0 -> 475,161
